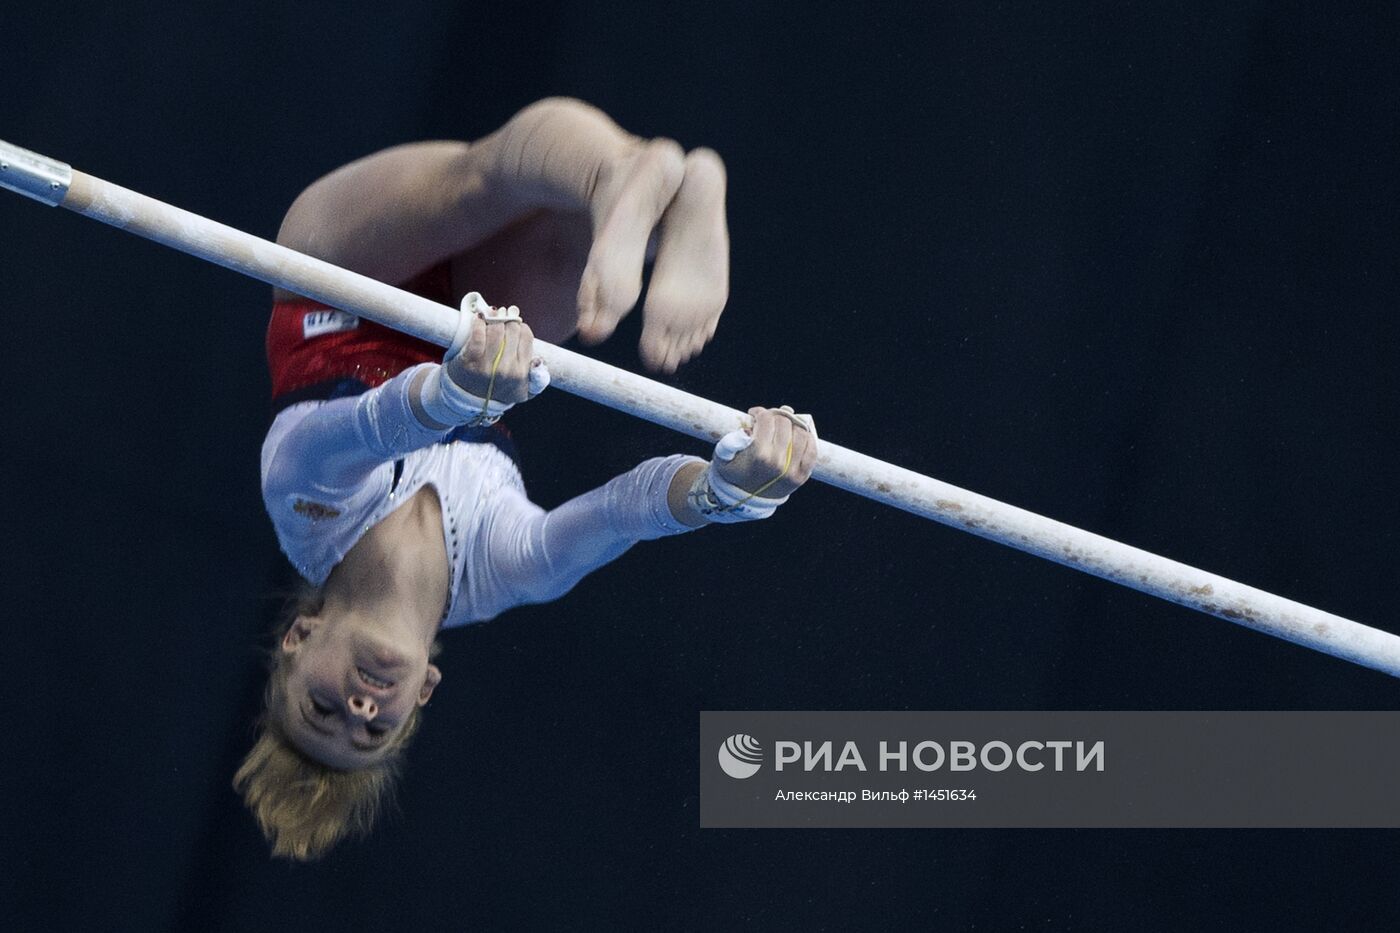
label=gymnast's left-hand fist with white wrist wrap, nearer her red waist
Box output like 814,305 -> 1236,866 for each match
420,308 -> 549,424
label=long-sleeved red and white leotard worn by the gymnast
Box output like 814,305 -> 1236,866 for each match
262,266 -> 699,626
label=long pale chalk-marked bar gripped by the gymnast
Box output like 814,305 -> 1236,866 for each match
0,141 -> 1400,677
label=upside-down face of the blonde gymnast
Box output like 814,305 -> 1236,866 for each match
272,616 -> 442,770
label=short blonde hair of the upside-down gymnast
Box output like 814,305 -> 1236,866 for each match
234,588 -> 437,862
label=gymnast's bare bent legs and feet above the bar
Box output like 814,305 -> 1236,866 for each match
277,97 -> 729,373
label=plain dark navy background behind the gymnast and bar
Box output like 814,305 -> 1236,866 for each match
0,0 -> 1400,930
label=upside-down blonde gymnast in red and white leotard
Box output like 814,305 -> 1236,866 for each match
234,99 -> 816,860
